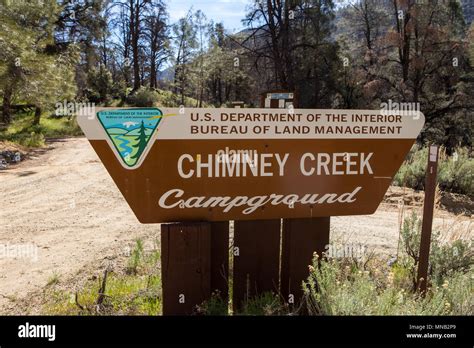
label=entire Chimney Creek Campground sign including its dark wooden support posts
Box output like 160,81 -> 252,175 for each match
78,105 -> 424,314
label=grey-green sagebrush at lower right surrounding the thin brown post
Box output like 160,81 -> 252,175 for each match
304,214 -> 474,315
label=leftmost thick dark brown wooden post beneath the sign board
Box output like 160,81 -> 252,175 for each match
161,222 -> 229,315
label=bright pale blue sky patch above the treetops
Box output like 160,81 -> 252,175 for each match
165,0 -> 248,32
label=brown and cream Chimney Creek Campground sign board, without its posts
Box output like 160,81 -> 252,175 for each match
79,108 -> 424,223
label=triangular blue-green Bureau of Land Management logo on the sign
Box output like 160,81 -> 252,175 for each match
97,108 -> 163,168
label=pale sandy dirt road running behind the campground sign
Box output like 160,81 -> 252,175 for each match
0,138 -> 472,314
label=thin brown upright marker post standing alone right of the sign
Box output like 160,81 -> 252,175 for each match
417,145 -> 439,293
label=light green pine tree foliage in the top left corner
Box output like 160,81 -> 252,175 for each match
0,0 -> 79,124
